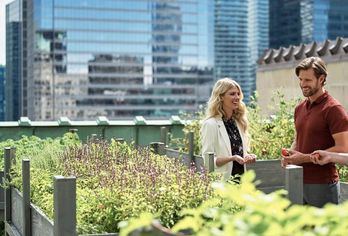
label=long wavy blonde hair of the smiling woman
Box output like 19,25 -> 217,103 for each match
206,78 -> 248,133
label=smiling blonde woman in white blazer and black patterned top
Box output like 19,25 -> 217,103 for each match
201,78 -> 256,180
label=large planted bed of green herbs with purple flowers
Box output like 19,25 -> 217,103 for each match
6,136 -> 212,234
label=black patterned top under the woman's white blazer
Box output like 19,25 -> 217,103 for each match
223,119 -> 244,176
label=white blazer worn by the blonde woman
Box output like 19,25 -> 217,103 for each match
201,117 -> 249,180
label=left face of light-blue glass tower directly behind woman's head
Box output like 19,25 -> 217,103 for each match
214,0 -> 253,102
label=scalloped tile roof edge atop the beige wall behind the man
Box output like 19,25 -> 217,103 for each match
257,37 -> 348,66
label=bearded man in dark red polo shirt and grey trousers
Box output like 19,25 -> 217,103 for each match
282,57 -> 348,207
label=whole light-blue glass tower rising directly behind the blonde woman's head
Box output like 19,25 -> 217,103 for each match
214,0 -> 268,103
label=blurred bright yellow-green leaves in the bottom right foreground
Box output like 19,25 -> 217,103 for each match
121,172 -> 348,236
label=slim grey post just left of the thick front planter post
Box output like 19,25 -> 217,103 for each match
22,159 -> 31,236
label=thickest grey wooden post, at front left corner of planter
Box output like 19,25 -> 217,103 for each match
53,176 -> 77,236
